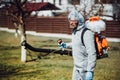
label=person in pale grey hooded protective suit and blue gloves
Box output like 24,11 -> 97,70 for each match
57,10 -> 96,80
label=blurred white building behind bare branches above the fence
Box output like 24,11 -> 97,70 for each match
0,0 -> 120,20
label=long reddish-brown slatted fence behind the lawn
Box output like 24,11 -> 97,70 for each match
0,16 -> 120,38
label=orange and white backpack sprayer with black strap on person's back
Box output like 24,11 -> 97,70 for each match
81,16 -> 109,58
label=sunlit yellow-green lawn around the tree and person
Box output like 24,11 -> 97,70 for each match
0,31 -> 120,80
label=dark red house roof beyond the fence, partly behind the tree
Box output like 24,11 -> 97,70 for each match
8,2 -> 60,13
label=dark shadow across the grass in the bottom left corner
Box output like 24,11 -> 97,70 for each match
0,63 -> 48,80
